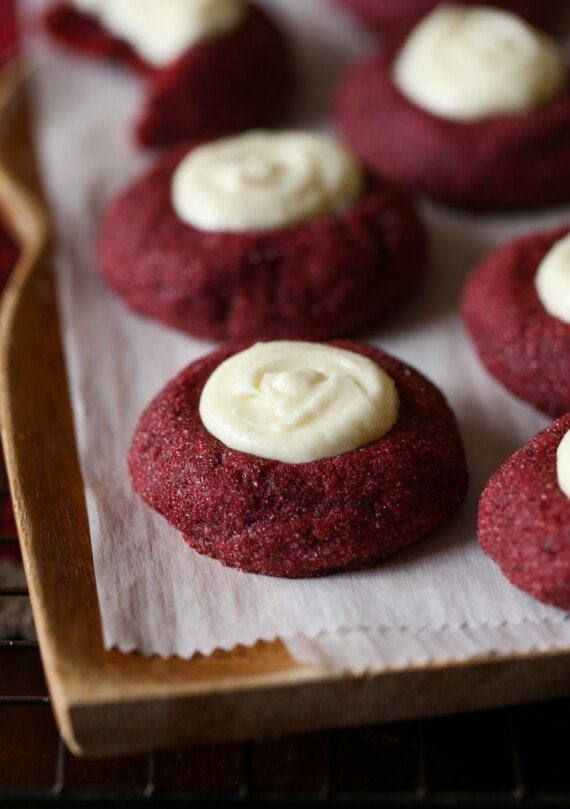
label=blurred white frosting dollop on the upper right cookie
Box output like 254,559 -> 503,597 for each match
393,5 -> 567,121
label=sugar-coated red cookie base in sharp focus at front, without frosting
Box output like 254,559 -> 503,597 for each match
129,341 -> 467,578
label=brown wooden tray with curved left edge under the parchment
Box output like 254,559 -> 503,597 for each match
0,58 -> 570,756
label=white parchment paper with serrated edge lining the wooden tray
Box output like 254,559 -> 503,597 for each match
26,0 -> 570,670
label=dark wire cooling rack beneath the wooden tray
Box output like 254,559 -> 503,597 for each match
0,486 -> 570,809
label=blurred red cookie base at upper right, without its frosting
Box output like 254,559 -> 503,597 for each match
336,38 -> 570,210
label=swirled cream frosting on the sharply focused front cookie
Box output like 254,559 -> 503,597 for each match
200,340 -> 398,463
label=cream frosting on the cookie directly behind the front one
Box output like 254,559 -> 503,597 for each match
172,131 -> 364,232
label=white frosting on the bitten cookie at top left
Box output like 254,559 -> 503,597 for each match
72,0 -> 246,67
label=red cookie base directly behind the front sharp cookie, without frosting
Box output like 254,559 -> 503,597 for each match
99,144 -> 427,340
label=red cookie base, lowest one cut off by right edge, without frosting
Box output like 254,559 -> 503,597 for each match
479,414 -> 570,610
